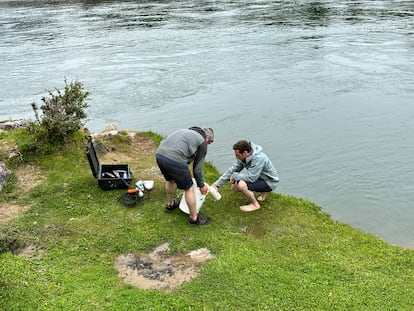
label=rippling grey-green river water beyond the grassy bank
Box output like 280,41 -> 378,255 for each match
0,0 -> 414,248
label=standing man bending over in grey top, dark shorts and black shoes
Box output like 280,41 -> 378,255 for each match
156,126 -> 214,225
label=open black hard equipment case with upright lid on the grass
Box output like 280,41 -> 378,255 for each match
86,137 -> 133,190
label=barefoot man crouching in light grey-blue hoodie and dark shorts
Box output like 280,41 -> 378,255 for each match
213,140 -> 279,212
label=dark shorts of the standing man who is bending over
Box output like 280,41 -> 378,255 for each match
155,154 -> 193,190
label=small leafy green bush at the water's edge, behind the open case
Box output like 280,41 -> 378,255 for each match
31,79 -> 89,144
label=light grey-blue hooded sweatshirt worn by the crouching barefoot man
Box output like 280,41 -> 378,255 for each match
214,142 -> 279,190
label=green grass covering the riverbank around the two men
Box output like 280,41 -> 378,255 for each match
0,132 -> 414,310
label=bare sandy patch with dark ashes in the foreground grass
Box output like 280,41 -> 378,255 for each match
115,243 -> 213,291
